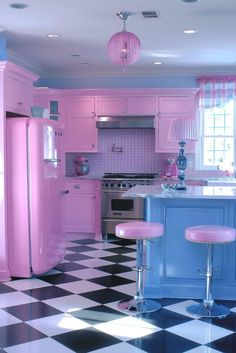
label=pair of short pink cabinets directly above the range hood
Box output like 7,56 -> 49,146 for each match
97,96 -> 156,115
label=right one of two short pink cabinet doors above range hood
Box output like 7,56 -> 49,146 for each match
126,96 -> 156,115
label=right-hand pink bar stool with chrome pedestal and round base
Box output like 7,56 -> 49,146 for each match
185,225 -> 236,318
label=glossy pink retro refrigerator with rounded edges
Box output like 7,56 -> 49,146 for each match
6,118 -> 65,277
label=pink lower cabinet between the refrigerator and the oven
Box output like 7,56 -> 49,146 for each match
64,180 -> 101,239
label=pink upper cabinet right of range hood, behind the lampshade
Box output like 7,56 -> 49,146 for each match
155,94 -> 196,153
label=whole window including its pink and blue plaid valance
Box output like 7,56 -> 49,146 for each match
197,76 -> 236,172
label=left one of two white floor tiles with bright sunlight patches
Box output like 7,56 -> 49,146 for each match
26,314 -> 90,336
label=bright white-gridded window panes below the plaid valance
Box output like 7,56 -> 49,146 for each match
198,99 -> 236,170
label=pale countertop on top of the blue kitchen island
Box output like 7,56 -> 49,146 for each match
123,185 -> 236,200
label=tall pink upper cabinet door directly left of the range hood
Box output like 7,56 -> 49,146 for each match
66,97 -> 97,152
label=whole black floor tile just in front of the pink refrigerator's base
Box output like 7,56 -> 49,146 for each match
22,279 -> 72,300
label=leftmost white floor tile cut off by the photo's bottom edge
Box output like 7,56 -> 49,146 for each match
4,338 -> 74,353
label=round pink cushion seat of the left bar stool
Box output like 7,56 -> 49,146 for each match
115,221 -> 163,239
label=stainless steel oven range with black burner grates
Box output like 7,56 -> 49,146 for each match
101,173 -> 157,239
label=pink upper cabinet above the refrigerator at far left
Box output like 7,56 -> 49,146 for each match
4,63 -> 38,116
